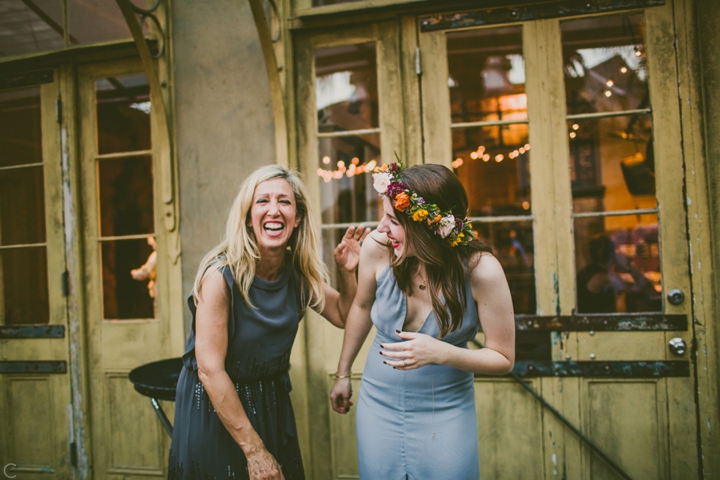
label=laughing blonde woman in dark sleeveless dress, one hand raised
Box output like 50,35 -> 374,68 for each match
168,165 -> 367,480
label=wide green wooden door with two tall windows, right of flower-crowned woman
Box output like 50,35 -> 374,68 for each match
419,1 -> 698,479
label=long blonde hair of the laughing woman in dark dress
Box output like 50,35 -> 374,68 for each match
193,165 -> 328,311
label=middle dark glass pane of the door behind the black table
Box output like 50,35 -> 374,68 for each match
98,156 -> 154,237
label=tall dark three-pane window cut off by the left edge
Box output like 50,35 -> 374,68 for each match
0,88 -> 50,325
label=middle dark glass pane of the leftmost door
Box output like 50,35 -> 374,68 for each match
0,166 -> 45,245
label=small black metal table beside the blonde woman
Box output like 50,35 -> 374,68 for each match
128,357 -> 183,437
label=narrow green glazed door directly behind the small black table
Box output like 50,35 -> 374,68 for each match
78,61 -> 172,478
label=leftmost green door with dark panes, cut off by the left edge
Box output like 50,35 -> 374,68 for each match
0,77 -> 71,479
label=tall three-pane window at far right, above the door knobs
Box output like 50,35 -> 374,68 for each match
560,14 -> 662,313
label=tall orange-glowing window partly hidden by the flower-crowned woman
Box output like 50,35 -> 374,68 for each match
446,26 -> 537,314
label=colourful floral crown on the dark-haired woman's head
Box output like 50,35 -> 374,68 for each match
373,161 -> 476,247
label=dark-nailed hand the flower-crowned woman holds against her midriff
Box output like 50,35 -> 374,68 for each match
380,331 -> 448,370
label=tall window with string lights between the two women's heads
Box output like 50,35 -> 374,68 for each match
314,42 -> 382,265
